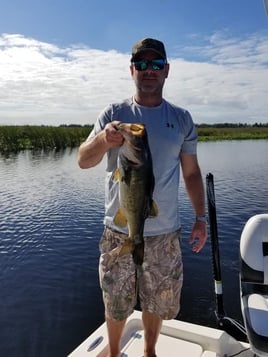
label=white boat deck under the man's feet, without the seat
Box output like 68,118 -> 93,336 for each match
69,311 -> 254,357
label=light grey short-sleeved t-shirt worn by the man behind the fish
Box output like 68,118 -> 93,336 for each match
88,98 -> 197,236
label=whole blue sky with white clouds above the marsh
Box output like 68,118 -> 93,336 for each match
0,0 -> 268,126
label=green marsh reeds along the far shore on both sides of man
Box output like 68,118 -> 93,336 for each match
0,123 -> 268,154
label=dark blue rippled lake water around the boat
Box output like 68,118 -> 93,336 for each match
0,140 -> 268,357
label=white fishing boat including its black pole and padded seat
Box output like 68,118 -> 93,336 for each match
69,174 -> 268,357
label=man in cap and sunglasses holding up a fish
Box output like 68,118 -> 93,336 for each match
78,38 -> 207,357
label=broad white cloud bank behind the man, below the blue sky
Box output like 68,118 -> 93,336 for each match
0,33 -> 268,125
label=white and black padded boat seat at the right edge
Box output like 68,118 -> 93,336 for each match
240,214 -> 268,357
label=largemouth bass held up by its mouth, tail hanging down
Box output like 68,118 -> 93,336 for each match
114,123 -> 158,265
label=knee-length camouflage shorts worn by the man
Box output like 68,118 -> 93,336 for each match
99,228 -> 183,320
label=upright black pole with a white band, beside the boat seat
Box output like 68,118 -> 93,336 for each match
206,173 -> 225,325
